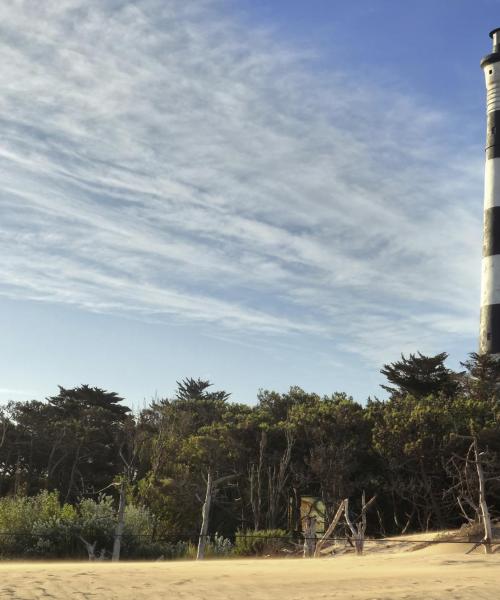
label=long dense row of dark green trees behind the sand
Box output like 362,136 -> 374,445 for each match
0,353 -> 500,543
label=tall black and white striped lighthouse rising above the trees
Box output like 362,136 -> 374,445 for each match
479,28 -> 500,356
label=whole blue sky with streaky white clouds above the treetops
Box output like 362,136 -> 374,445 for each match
0,0 -> 499,407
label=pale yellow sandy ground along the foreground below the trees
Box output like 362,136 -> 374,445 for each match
0,547 -> 500,600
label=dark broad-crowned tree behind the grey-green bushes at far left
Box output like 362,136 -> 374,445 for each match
10,385 -> 130,502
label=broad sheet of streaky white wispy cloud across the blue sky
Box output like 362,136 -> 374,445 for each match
0,0 -> 482,360
